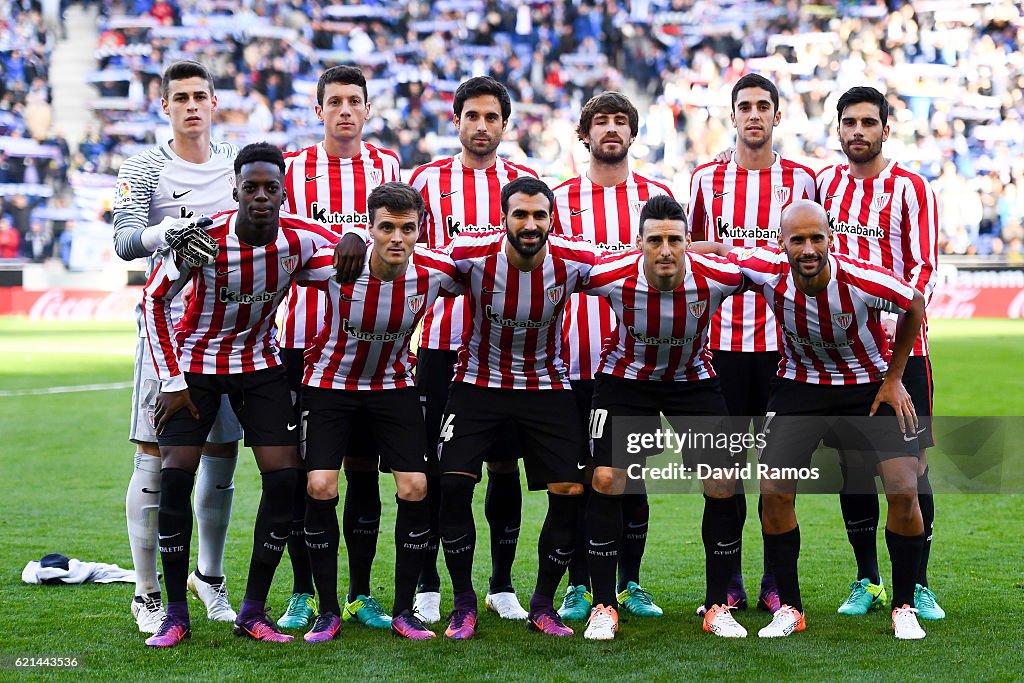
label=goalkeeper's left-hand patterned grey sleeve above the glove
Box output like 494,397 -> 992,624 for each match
113,155 -> 163,261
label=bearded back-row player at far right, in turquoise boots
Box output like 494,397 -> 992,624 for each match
817,87 -> 945,620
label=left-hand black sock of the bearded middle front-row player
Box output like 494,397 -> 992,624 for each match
440,474 -> 476,595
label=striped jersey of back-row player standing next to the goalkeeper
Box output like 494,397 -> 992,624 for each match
281,142 -> 399,348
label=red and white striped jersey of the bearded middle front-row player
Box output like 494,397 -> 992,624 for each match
451,230 -> 598,389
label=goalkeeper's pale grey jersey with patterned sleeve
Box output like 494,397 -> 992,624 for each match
114,140 -> 239,337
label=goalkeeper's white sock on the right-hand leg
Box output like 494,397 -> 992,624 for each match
195,456 -> 239,577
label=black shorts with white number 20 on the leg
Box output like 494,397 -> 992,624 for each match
590,373 -> 745,470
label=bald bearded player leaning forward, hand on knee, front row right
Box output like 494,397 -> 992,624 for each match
697,201 -> 925,640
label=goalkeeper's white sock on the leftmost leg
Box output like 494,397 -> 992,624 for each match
125,453 -> 160,595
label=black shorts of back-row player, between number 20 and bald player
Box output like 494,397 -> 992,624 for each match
711,351 -> 779,417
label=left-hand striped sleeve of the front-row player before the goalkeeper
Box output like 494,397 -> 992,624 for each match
142,258 -> 196,391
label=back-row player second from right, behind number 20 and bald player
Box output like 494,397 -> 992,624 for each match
690,74 -> 814,614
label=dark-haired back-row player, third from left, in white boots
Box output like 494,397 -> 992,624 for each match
410,77 -> 537,624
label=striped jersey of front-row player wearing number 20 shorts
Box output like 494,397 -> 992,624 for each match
583,252 -> 746,382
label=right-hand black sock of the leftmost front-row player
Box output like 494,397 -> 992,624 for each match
245,468 -> 298,602
